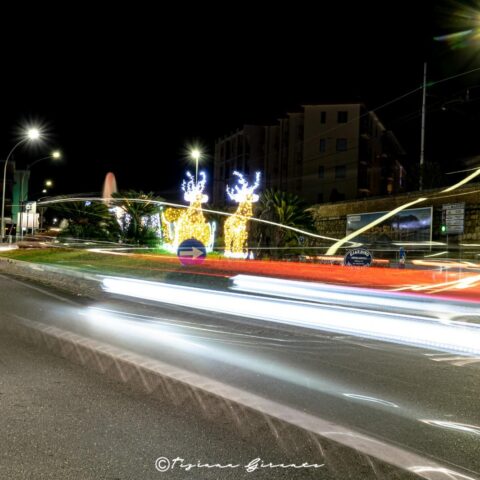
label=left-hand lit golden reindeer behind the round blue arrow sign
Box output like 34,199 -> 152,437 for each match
164,172 -> 215,252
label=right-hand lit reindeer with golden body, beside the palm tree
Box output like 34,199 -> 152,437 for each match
224,171 -> 260,258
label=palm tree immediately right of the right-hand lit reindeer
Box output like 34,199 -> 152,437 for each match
252,189 -> 313,256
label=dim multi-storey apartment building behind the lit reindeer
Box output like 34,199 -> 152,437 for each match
213,104 -> 405,205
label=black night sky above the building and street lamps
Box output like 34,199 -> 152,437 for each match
0,0 -> 480,198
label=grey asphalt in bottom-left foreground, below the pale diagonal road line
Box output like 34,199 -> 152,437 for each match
0,318 -> 342,480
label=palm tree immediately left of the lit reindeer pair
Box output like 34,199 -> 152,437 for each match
112,190 -> 163,244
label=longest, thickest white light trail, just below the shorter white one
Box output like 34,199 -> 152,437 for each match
103,277 -> 480,355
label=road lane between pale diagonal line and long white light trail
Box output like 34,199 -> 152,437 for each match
0,277 -> 480,478
